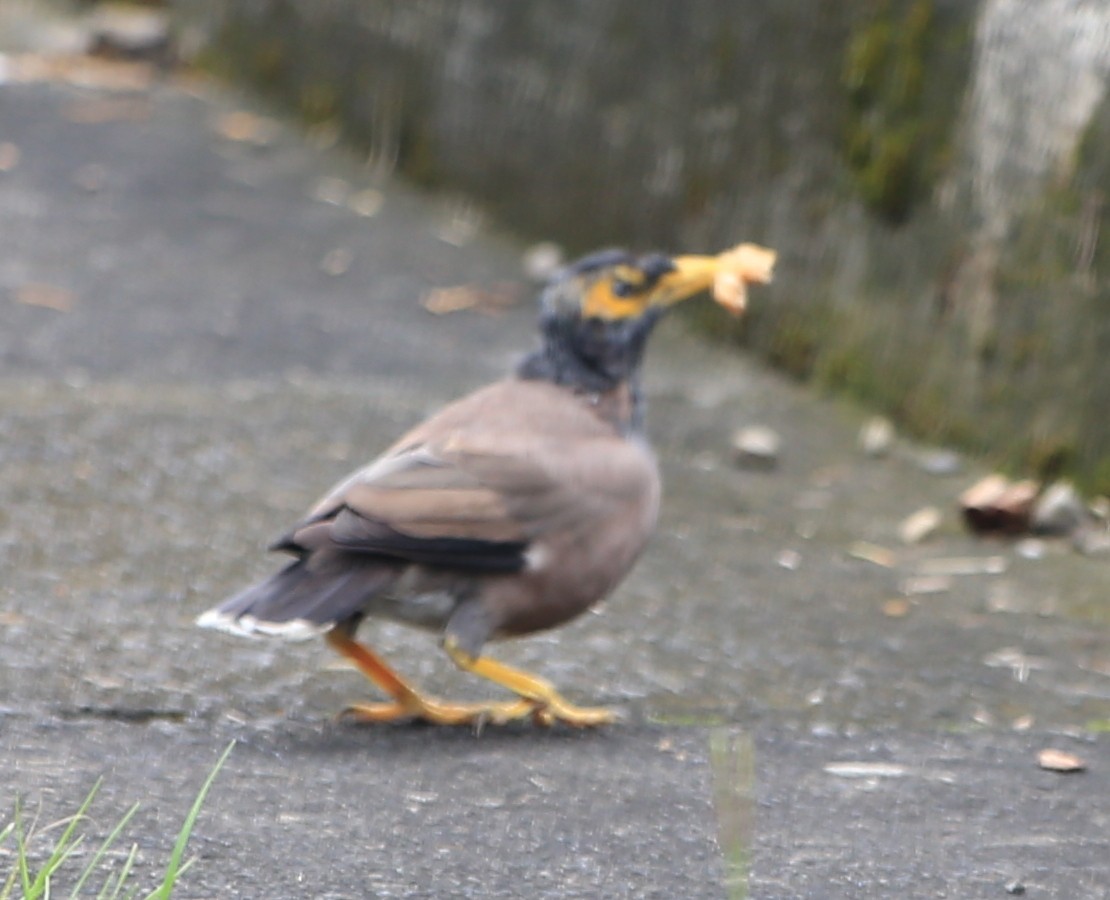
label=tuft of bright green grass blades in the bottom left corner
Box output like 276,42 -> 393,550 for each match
0,741 -> 235,900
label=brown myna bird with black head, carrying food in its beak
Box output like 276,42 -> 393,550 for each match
199,244 -> 774,726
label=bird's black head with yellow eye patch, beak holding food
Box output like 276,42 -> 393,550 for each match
522,244 -> 775,391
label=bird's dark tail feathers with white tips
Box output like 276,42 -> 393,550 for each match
196,556 -> 396,640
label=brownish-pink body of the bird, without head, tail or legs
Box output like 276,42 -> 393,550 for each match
293,380 -> 659,654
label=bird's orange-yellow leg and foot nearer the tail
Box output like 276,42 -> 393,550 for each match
326,629 -> 535,726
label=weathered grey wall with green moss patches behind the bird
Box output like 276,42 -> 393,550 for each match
170,0 -> 1110,491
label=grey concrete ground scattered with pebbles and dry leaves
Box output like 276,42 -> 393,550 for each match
0,33 -> 1110,900
